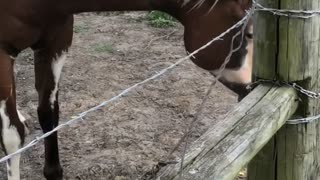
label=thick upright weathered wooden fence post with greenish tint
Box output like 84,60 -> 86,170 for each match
248,0 -> 320,180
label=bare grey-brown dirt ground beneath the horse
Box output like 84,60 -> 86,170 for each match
0,12 -> 240,180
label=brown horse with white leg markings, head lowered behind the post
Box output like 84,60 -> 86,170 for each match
0,0 -> 252,180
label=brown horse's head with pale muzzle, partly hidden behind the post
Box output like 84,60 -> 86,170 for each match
179,0 -> 253,99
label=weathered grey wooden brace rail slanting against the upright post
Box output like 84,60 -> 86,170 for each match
157,85 -> 297,180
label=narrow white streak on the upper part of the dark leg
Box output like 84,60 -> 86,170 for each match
50,52 -> 67,109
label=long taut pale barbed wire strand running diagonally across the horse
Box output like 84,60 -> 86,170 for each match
0,9 -> 248,163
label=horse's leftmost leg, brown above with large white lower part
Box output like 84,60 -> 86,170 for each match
0,50 -> 25,180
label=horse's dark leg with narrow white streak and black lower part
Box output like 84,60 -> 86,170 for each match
33,17 -> 73,180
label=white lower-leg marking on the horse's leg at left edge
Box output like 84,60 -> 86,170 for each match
0,101 -> 21,180
